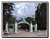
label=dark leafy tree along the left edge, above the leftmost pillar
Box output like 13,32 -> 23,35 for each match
3,3 -> 13,30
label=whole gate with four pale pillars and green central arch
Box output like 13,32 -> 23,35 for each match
6,20 -> 37,33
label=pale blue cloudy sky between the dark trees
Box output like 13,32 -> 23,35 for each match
12,3 -> 38,20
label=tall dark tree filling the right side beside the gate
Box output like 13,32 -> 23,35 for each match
36,3 -> 47,30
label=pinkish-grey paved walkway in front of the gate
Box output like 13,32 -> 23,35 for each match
3,30 -> 47,37
